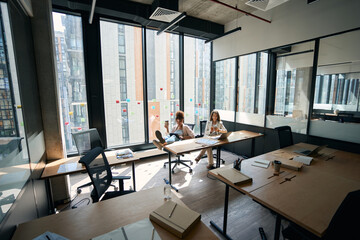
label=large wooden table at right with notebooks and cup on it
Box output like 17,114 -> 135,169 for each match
210,143 -> 360,239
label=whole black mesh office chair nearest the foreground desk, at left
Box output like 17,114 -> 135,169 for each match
79,147 -> 134,202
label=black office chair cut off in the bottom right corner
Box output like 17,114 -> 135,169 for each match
282,190 -> 360,240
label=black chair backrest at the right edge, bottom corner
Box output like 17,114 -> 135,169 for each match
324,190 -> 360,240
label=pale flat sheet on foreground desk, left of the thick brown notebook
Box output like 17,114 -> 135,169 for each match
93,218 -> 161,240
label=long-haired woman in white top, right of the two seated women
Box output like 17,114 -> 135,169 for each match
195,110 -> 227,169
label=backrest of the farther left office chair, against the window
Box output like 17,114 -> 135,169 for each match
72,128 -> 104,155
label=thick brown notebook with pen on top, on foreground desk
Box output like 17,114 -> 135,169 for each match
150,201 -> 201,238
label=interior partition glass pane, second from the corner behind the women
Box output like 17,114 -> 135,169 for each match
236,53 -> 268,127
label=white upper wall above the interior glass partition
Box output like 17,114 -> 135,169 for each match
213,0 -> 360,60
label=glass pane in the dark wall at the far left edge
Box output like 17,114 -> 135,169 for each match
0,3 -> 30,223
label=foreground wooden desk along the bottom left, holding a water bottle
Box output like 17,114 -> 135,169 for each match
12,187 -> 218,240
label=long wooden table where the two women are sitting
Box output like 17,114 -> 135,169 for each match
164,130 -> 264,190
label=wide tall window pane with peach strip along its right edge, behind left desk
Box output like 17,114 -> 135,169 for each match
100,21 -> 145,147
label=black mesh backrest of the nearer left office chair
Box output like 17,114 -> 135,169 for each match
79,147 -> 112,202
